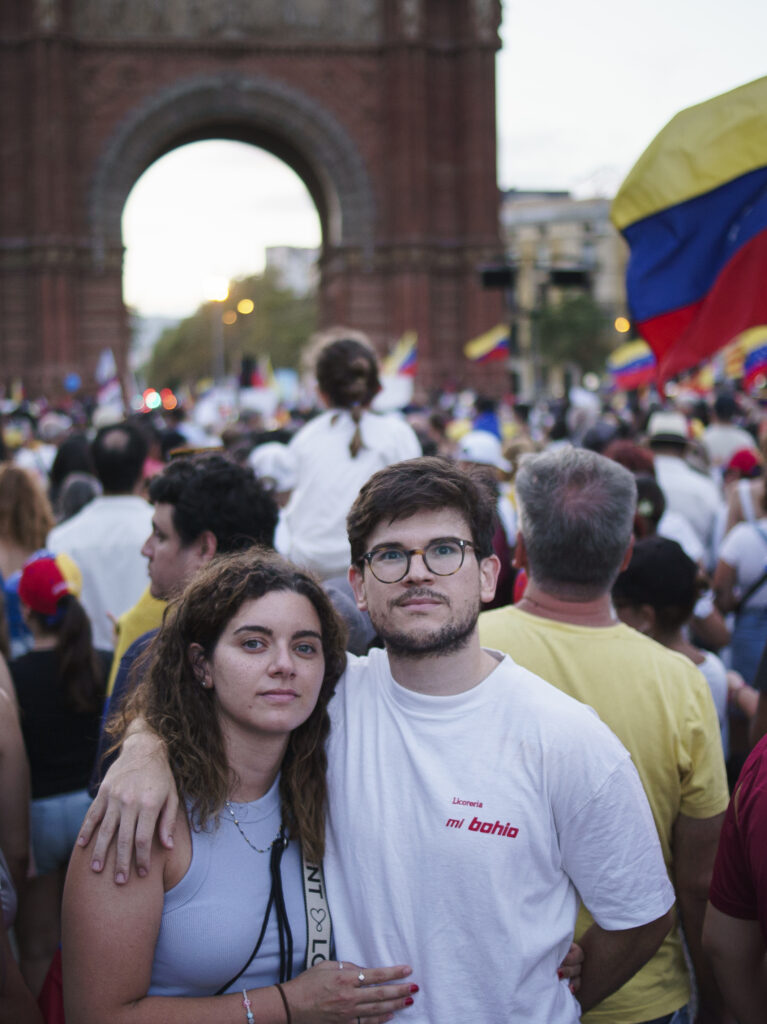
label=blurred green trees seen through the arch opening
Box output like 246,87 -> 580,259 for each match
145,270 -> 316,388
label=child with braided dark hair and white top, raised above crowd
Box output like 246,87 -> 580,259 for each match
283,329 -> 422,580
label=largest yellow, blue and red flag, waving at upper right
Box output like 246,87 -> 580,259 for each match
610,78 -> 767,382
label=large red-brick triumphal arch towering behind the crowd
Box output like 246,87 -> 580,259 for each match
0,0 -> 501,394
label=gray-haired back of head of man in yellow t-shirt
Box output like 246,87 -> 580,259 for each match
515,447 -> 637,600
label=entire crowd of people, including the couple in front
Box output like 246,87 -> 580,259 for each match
0,331 -> 767,1024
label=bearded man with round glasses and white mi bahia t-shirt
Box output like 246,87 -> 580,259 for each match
80,458 -> 674,1024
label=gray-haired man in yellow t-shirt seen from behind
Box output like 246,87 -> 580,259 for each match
479,447 -> 727,1024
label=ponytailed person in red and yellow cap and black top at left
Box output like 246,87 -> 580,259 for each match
10,552 -> 109,993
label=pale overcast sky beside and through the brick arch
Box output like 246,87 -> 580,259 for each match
123,0 -> 767,316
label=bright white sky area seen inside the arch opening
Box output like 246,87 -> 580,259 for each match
122,137 -> 322,318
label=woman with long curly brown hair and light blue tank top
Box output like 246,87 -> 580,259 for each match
62,551 -> 412,1024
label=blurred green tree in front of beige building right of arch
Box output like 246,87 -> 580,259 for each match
534,295 -> 613,372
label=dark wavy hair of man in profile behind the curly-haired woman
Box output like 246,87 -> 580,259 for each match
150,454 -> 279,554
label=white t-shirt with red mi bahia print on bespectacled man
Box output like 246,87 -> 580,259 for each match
325,650 -> 674,1024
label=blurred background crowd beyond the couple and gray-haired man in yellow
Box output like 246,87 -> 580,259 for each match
0,332 -> 767,1020
